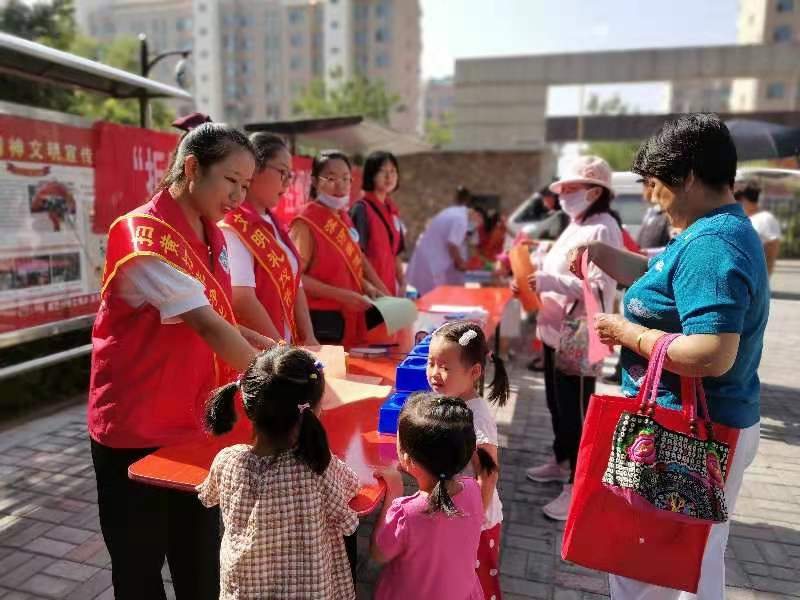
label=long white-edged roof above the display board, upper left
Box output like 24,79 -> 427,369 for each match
0,32 -> 192,100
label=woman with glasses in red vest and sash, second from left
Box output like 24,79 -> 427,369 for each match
220,132 -> 319,346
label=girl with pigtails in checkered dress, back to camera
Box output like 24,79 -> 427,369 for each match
198,345 -> 358,600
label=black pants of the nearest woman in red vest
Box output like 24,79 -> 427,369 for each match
92,440 -> 220,600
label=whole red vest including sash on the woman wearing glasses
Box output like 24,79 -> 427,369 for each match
220,202 -> 300,342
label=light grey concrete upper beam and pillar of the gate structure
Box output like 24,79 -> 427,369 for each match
452,44 -> 798,150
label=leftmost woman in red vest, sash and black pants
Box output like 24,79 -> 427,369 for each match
88,123 -> 269,600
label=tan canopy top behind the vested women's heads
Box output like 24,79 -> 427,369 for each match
244,116 -> 433,156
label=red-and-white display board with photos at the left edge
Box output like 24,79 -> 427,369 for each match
0,115 -> 102,334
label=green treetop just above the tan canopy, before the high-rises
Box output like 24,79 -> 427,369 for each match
292,76 -> 402,125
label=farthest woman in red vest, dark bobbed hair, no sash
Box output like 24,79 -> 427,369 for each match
350,151 -> 406,296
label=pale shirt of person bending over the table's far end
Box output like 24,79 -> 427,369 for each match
406,206 -> 469,295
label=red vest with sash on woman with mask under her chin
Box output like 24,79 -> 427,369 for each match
295,202 -> 366,347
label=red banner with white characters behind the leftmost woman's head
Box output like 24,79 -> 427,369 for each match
92,122 -> 178,234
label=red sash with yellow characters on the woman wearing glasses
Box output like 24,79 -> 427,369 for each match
219,209 -> 300,342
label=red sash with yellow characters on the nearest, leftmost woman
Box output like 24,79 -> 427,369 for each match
100,213 -> 237,385
